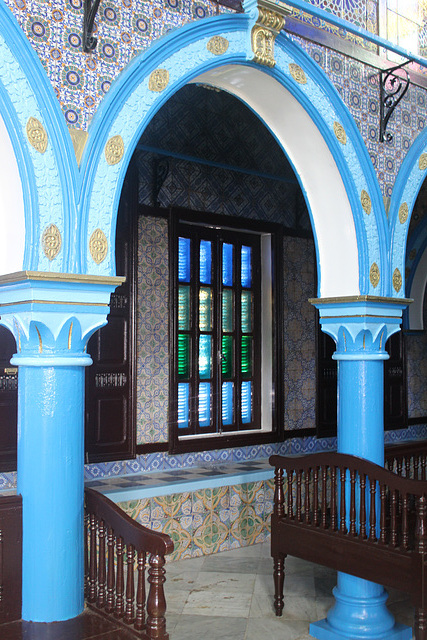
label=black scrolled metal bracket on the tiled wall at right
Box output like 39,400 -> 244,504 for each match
380,60 -> 412,142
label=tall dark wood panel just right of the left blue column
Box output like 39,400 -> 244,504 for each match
86,165 -> 138,462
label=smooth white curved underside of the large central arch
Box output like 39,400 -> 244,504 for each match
193,65 -> 360,298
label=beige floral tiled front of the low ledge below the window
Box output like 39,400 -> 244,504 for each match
119,480 -> 274,560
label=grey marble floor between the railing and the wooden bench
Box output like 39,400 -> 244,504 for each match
165,543 -> 413,640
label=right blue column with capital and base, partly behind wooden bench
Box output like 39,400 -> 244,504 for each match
310,296 -> 412,640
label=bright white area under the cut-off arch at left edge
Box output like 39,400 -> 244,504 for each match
0,116 -> 25,275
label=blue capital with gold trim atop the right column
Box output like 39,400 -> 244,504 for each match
309,296 -> 412,360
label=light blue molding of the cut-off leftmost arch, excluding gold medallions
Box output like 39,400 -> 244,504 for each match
0,2 -> 79,272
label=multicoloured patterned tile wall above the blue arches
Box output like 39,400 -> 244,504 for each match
6,0 -> 426,195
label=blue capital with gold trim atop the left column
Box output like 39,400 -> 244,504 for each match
0,271 -> 124,366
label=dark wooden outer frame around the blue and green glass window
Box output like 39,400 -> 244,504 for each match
169,208 -> 284,454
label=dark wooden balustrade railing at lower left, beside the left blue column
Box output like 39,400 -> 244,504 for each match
85,489 -> 173,640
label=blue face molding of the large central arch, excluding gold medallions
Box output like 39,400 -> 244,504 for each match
78,14 -> 391,295
